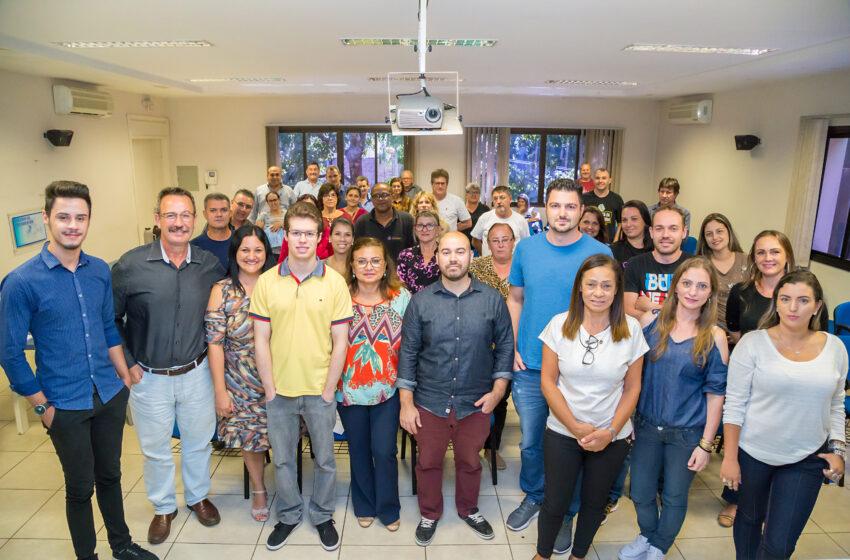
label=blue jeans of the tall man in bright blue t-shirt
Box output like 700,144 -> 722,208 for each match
511,369 -> 549,504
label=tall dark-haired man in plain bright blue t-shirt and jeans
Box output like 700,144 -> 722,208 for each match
506,178 -> 611,531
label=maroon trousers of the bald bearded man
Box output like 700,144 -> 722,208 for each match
416,406 -> 490,520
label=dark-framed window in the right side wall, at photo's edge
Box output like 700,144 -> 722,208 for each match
812,126 -> 850,270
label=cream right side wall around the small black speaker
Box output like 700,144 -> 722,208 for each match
653,71 -> 850,306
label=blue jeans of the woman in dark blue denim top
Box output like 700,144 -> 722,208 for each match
631,416 -> 703,554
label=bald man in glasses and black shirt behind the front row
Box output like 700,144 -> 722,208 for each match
354,183 -> 415,262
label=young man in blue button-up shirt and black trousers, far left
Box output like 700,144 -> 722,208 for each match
0,181 -> 156,560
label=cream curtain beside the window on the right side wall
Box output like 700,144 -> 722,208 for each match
785,117 -> 829,266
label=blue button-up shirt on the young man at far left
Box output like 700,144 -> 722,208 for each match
0,243 -> 124,410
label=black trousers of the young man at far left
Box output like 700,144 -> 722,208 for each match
47,388 -> 131,558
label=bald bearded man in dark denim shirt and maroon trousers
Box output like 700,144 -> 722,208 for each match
396,232 -> 514,546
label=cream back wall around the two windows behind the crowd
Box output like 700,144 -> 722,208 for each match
168,95 -> 659,201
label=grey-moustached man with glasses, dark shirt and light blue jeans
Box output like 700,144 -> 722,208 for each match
112,187 -> 224,544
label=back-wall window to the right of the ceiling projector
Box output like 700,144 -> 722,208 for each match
508,129 -> 581,205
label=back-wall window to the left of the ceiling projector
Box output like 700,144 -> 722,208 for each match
278,127 -> 407,186
